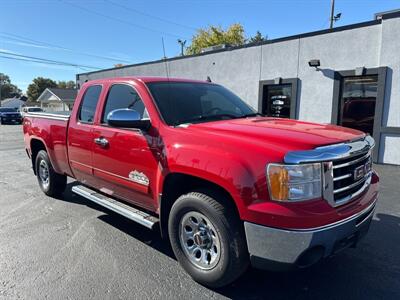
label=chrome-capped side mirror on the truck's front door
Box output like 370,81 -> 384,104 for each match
107,108 -> 151,130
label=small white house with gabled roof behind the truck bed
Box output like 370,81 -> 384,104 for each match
37,88 -> 77,111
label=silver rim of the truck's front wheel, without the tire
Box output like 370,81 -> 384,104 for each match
179,211 -> 221,270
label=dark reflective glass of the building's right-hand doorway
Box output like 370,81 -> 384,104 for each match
338,75 -> 378,135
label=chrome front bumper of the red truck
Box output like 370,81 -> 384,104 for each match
244,199 -> 376,270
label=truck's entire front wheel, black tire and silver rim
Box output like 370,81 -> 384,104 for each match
168,191 -> 248,288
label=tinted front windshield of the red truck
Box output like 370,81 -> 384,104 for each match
147,82 -> 256,126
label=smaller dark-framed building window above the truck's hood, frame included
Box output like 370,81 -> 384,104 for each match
259,78 -> 298,119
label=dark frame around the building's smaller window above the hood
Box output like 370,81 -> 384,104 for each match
258,77 -> 299,119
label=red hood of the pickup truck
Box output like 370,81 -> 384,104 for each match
188,117 -> 365,151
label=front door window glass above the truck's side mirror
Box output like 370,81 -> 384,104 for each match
102,84 -> 148,123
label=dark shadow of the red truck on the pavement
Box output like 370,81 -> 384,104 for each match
60,183 -> 400,299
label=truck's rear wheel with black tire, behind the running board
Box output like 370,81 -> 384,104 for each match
35,150 -> 67,197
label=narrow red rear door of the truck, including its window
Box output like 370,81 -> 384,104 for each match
68,85 -> 102,185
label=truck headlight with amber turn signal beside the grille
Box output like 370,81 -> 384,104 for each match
267,163 -> 322,201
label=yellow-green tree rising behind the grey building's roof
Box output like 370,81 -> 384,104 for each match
186,23 -> 246,55
